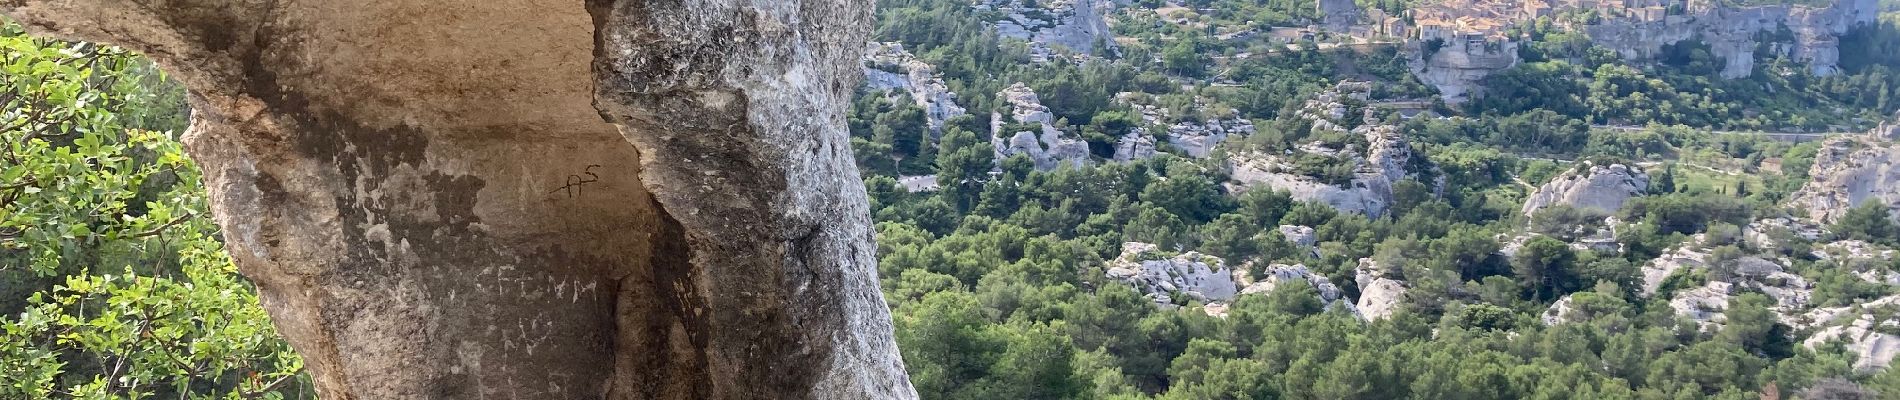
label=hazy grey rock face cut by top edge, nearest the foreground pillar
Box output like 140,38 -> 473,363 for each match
977,0 -> 1115,55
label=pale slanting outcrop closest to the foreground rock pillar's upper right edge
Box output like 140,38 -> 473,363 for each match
865,42 -> 969,135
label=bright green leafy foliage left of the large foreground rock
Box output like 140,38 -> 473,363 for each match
0,25 -> 314,398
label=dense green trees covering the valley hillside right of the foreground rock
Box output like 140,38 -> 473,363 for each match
855,2 -> 1900,398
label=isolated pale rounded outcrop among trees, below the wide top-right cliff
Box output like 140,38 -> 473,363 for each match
1524,163 -> 1649,216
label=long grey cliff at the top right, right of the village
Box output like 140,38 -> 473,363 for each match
1585,0 -> 1879,78
